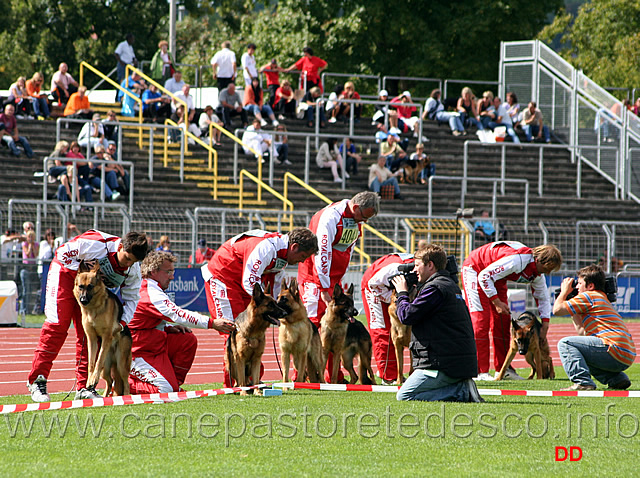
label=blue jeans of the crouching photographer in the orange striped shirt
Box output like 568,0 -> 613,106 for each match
558,336 -> 629,387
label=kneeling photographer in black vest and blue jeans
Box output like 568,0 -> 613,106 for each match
391,244 -> 483,402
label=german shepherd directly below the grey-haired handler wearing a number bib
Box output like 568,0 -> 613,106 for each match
320,284 -> 358,383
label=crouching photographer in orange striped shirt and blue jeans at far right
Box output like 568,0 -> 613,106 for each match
553,265 -> 636,390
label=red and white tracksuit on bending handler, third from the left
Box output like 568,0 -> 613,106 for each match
201,229 -> 289,387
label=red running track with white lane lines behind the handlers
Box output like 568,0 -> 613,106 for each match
0,322 -> 640,396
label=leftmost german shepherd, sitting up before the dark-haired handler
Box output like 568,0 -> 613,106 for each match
73,261 -> 132,397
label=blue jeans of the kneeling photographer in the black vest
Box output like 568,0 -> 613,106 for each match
396,369 -> 469,402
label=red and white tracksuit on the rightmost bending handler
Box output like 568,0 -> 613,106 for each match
462,241 -> 551,373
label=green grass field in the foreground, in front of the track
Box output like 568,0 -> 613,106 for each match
0,364 -> 640,477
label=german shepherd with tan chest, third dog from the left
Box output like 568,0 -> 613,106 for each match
278,279 -> 324,383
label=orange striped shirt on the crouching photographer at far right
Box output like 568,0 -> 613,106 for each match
565,290 -> 636,365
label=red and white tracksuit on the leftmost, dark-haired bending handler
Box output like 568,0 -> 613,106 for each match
28,230 -> 141,390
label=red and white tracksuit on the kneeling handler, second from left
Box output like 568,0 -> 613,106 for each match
129,279 -> 213,394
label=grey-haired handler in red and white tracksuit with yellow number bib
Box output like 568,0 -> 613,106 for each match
298,191 -> 380,380
